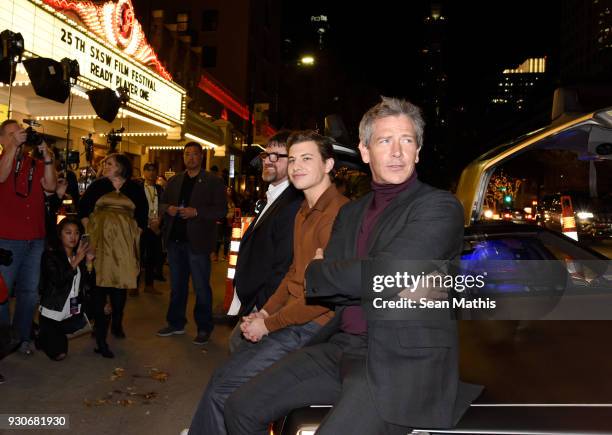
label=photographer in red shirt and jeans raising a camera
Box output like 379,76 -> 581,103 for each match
0,119 -> 57,355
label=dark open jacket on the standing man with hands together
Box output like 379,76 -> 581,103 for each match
160,169 -> 227,254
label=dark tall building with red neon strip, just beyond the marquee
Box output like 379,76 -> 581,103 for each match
134,0 -> 280,191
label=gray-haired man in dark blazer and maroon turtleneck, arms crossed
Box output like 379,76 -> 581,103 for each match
225,97 -> 480,435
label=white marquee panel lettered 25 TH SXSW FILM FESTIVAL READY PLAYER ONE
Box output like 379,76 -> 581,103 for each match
0,0 -> 185,124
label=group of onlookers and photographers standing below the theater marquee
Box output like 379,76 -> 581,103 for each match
0,120 -> 233,374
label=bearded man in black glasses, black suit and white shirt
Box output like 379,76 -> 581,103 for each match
229,130 -> 304,352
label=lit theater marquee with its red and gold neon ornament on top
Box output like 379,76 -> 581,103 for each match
0,0 -> 185,125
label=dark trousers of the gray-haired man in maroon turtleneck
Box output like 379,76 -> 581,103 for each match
225,333 -> 410,435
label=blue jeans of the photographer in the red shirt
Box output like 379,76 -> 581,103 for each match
0,238 -> 45,341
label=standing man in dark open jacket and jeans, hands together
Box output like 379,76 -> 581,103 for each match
157,142 -> 227,345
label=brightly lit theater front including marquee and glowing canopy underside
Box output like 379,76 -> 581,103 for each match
0,0 -> 203,181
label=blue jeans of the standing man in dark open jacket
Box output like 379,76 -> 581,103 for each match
166,241 -> 214,333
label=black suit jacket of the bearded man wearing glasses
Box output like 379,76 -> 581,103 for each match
234,185 -> 304,315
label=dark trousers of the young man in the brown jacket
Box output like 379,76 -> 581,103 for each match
189,322 -> 321,435
